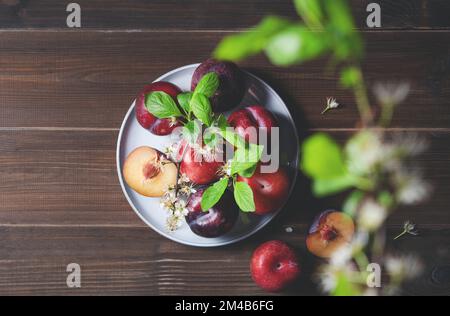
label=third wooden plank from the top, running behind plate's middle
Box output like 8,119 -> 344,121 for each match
0,130 -> 450,228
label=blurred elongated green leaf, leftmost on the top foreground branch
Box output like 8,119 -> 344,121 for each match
214,16 -> 292,61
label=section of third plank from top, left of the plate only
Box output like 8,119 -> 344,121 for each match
0,131 -> 136,226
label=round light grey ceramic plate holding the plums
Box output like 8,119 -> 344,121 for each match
116,64 -> 299,247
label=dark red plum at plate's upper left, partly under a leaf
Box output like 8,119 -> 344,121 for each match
135,81 -> 181,136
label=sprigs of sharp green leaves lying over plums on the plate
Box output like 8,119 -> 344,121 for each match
145,72 -> 263,212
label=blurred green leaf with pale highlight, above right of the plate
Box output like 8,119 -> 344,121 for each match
265,25 -> 329,66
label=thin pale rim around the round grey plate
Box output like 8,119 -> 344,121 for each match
116,63 -> 300,248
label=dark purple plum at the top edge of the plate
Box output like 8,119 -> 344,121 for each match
191,58 -> 245,112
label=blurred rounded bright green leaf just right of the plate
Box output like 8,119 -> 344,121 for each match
301,133 -> 347,180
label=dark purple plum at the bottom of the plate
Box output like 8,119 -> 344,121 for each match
186,188 -> 239,238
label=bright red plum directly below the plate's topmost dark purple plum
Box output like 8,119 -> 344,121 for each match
228,105 -> 278,144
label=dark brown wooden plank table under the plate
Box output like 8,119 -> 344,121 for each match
0,0 -> 450,295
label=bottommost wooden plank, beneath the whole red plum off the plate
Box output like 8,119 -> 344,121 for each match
0,226 -> 450,295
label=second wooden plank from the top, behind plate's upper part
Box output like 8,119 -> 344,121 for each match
0,31 -> 450,128
